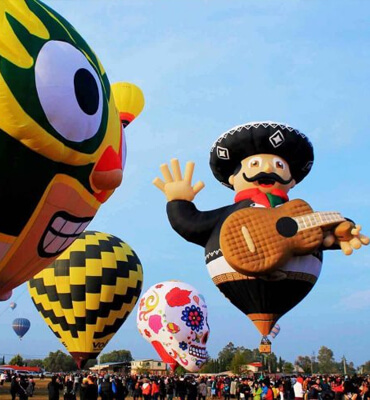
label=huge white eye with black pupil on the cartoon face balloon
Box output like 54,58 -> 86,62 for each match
35,41 -> 103,142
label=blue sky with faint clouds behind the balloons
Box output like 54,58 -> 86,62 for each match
0,0 -> 370,365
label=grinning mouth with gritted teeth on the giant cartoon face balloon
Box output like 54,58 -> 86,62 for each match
42,212 -> 92,257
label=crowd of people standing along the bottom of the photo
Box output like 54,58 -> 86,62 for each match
0,374 -> 370,400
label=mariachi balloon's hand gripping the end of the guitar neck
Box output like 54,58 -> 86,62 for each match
323,221 -> 370,256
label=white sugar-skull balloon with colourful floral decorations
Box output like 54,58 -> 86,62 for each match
137,281 -> 209,372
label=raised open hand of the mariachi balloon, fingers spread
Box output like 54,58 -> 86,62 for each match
153,158 -> 204,201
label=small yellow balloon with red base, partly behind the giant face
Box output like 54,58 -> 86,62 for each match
111,82 -> 145,127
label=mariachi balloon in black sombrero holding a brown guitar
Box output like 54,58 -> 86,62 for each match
153,121 -> 369,350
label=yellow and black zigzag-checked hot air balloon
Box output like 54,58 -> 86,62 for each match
28,231 -> 143,368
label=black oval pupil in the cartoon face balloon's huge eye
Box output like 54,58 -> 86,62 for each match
74,68 -> 99,115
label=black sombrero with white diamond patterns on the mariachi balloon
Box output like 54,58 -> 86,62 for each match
209,121 -> 314,188
